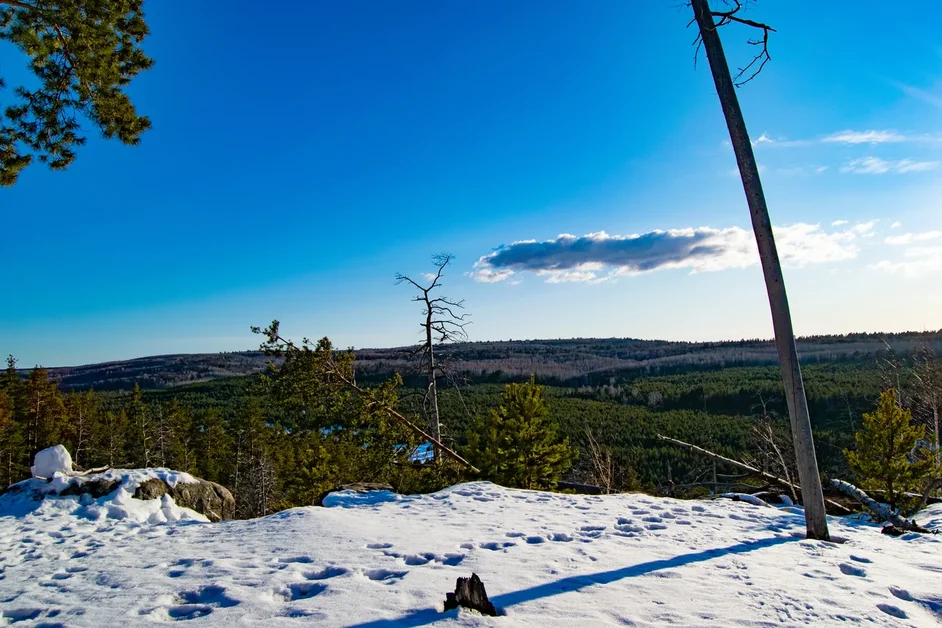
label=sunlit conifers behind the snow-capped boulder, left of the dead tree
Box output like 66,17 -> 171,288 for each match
0,359 -> 454,517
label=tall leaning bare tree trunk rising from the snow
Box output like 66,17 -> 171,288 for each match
691,0 -> 830,540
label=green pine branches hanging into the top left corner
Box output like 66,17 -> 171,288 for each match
0,0 -> 153,185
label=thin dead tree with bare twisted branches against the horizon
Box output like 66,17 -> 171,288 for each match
396,253 -> 470,448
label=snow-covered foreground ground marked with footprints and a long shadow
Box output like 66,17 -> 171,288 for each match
0,482 -> 942,628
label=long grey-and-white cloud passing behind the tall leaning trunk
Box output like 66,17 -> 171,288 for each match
471,221 -> 875,283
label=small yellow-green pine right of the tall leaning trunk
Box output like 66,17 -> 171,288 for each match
844,388 -> 934,509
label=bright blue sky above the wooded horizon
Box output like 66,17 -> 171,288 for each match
0,0 -> 942,366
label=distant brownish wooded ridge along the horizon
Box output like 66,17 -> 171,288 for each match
33,331 -> 942,390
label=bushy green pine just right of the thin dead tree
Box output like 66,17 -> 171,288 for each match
467,377 -> 576,489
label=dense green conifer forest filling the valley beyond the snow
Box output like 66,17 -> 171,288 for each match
0,334 -> 942,517
